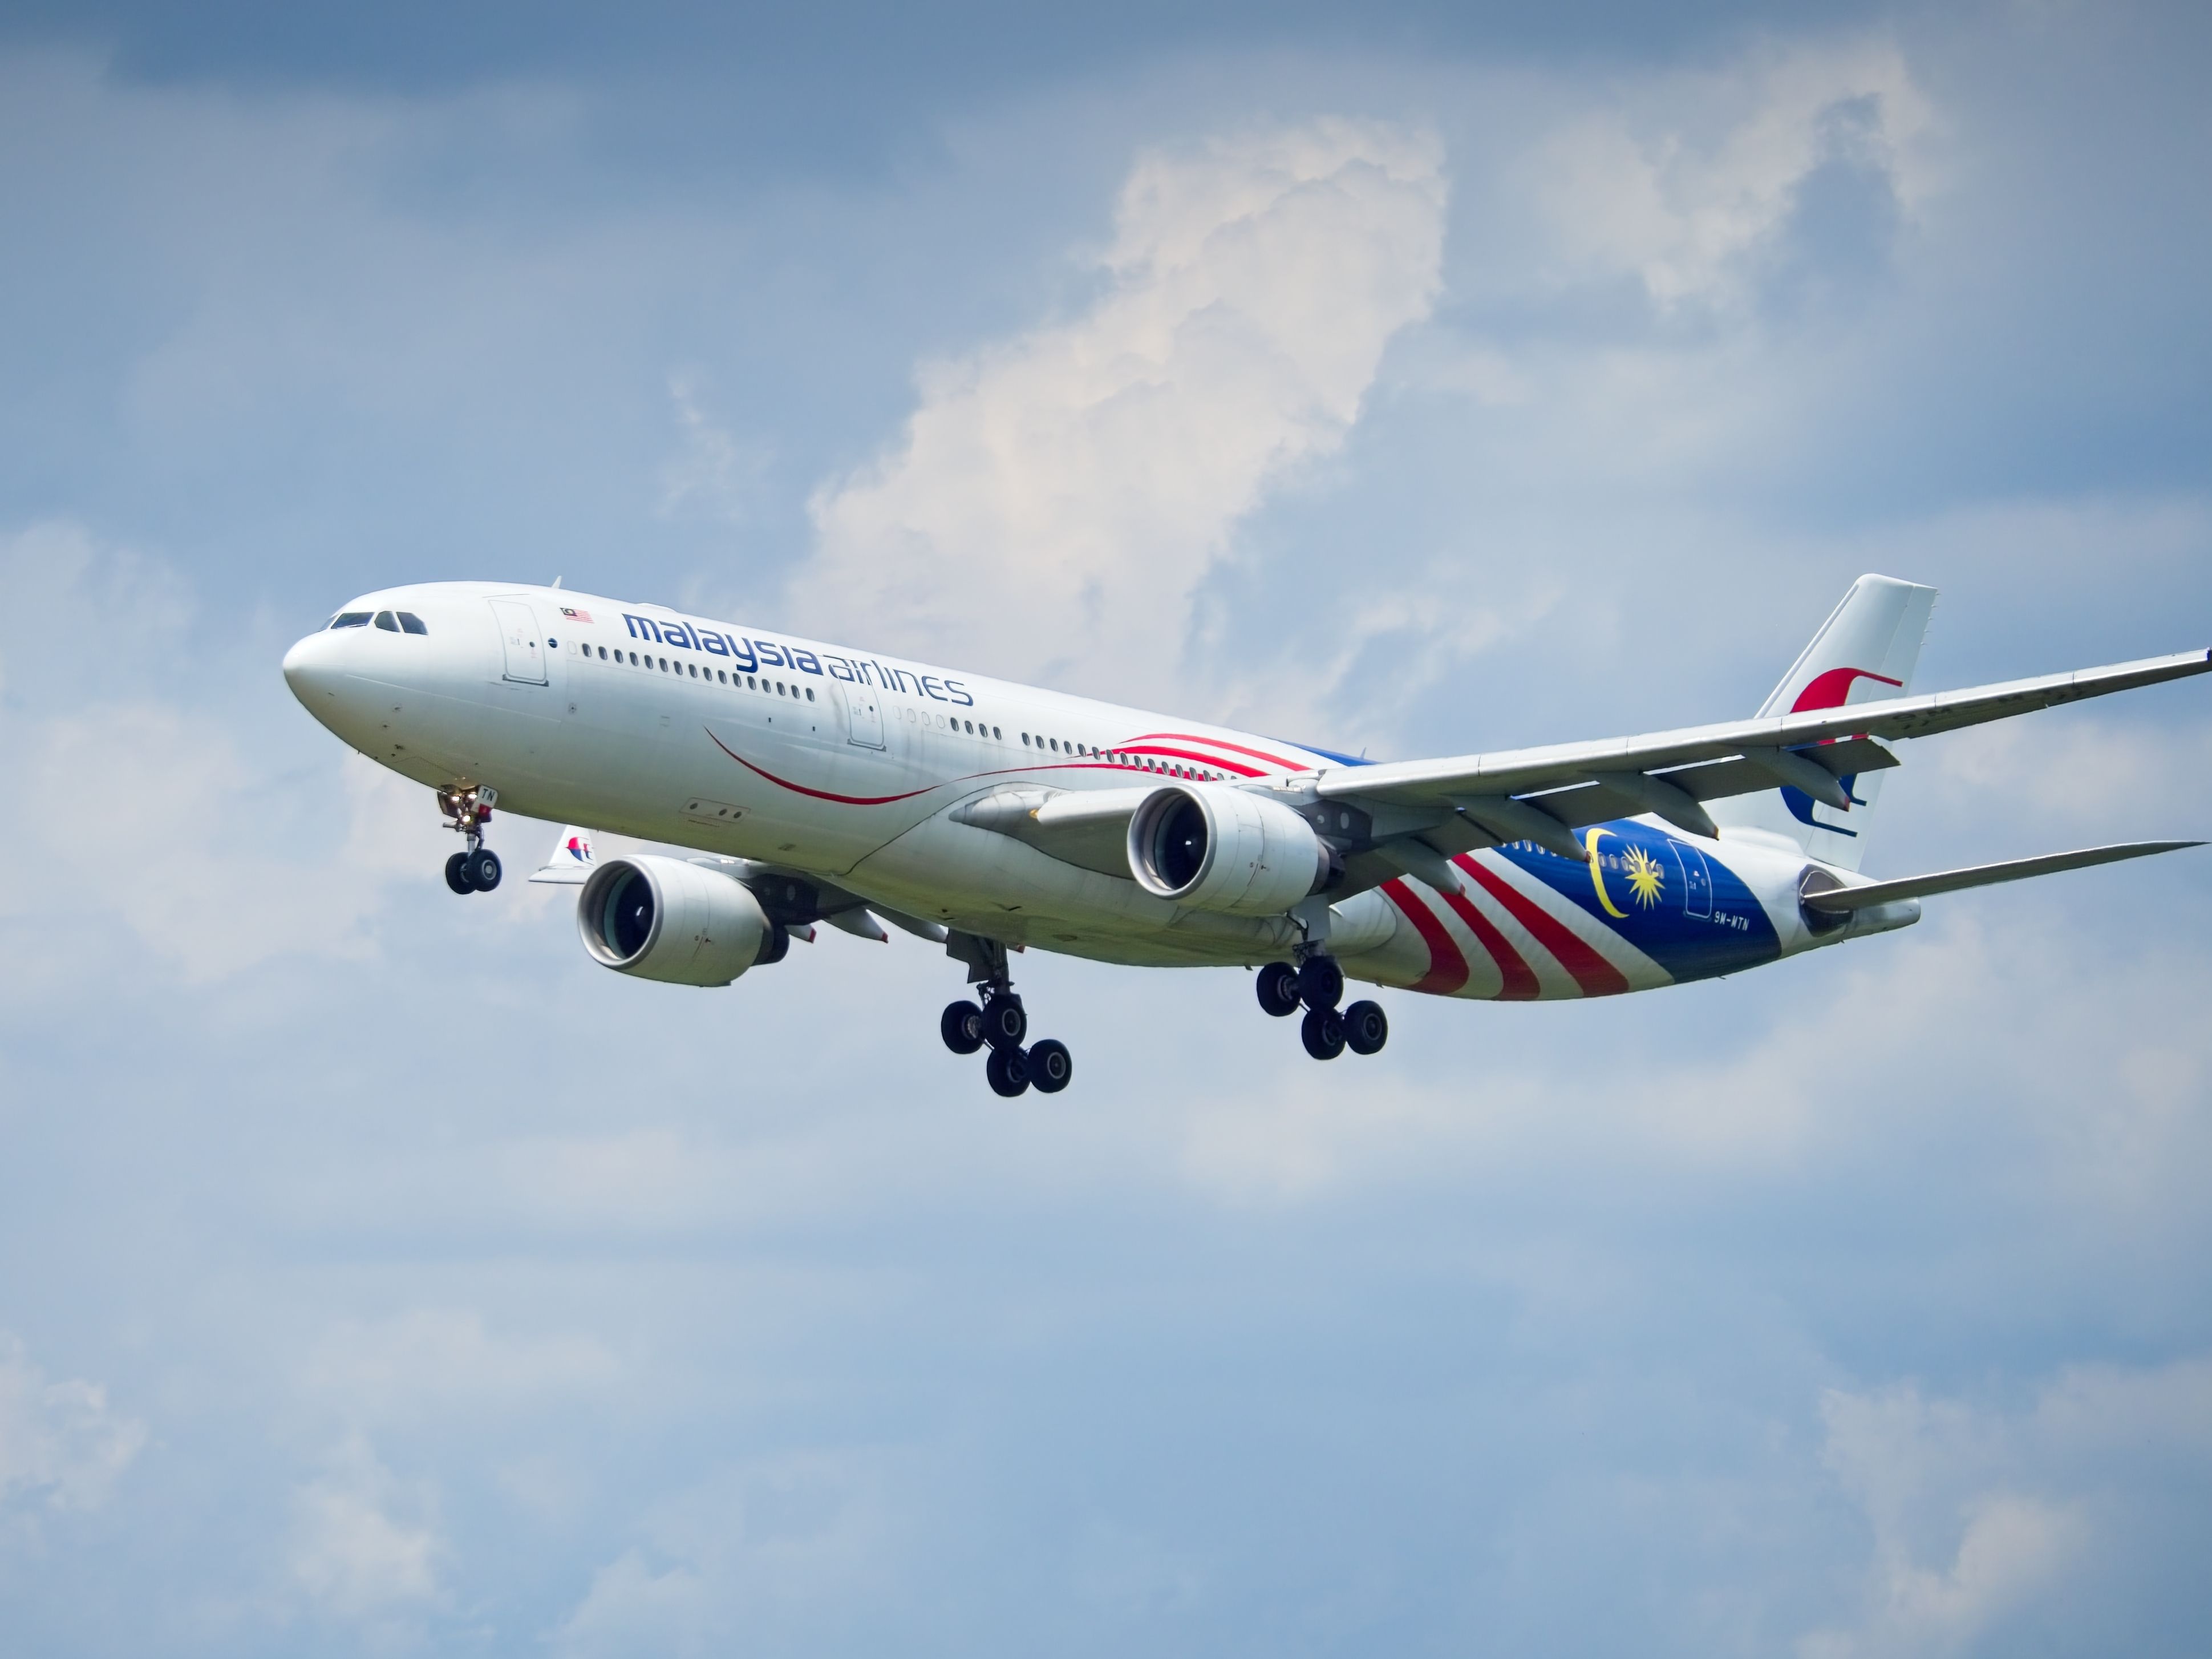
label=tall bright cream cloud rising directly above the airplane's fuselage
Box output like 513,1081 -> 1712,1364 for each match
796,119 -> 1447,694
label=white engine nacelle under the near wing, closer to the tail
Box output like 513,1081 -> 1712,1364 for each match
1128,783 -> 1336,916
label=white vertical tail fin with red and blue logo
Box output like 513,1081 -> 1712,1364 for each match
1712,575 -> 1935,869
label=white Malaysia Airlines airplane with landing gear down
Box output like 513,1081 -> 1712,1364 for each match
283,575 -> 2212,1097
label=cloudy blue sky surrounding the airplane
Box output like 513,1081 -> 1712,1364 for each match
0,0 -> 2212,1659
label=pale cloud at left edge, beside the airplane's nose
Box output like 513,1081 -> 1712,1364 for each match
0,522 -> 489,984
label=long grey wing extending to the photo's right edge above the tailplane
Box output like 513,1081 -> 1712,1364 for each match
1314,650 -> 2212,858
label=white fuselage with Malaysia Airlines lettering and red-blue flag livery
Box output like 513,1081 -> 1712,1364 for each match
285,582 -> 1885,1000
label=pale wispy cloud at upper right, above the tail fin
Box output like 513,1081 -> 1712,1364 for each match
1531,42 -> 1935,310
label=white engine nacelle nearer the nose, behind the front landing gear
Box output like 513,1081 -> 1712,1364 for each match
575,854 -> 789,984
